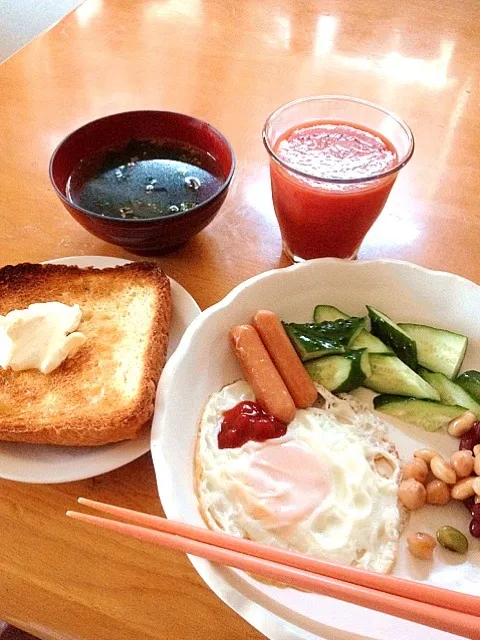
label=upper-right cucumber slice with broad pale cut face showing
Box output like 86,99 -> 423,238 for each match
398,322 -> 468,380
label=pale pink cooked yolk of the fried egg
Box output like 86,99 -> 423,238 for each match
239,442 -> 331,528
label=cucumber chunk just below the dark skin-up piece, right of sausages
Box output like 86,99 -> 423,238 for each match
305,349 -> 370,393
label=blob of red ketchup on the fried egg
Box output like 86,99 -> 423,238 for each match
218,401 -> 287,449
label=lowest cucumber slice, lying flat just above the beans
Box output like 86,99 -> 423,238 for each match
373,395 -> 465,431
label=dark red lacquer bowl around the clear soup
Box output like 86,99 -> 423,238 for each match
50,111 -> 235,255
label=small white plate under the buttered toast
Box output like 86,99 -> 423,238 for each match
0,256 -> 200,484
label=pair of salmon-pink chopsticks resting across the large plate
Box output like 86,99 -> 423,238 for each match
67,498 -> 480,640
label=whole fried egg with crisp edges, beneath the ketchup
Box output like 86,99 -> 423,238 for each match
196,380 -> 405,573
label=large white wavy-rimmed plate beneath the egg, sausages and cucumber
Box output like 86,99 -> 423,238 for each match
152,259 -> 480,640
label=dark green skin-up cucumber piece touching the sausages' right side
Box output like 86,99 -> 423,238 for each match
283,318 -> 365,362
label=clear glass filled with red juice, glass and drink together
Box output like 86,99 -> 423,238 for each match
264,96 -> 413,261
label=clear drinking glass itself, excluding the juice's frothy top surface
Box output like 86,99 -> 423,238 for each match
263,95 -> 414,262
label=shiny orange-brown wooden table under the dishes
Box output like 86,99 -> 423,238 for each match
0,0 -> 480,640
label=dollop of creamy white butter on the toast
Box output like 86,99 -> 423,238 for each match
0,302 -> 87,373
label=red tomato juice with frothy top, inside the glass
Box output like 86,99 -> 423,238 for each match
270,120 -> 398,260
